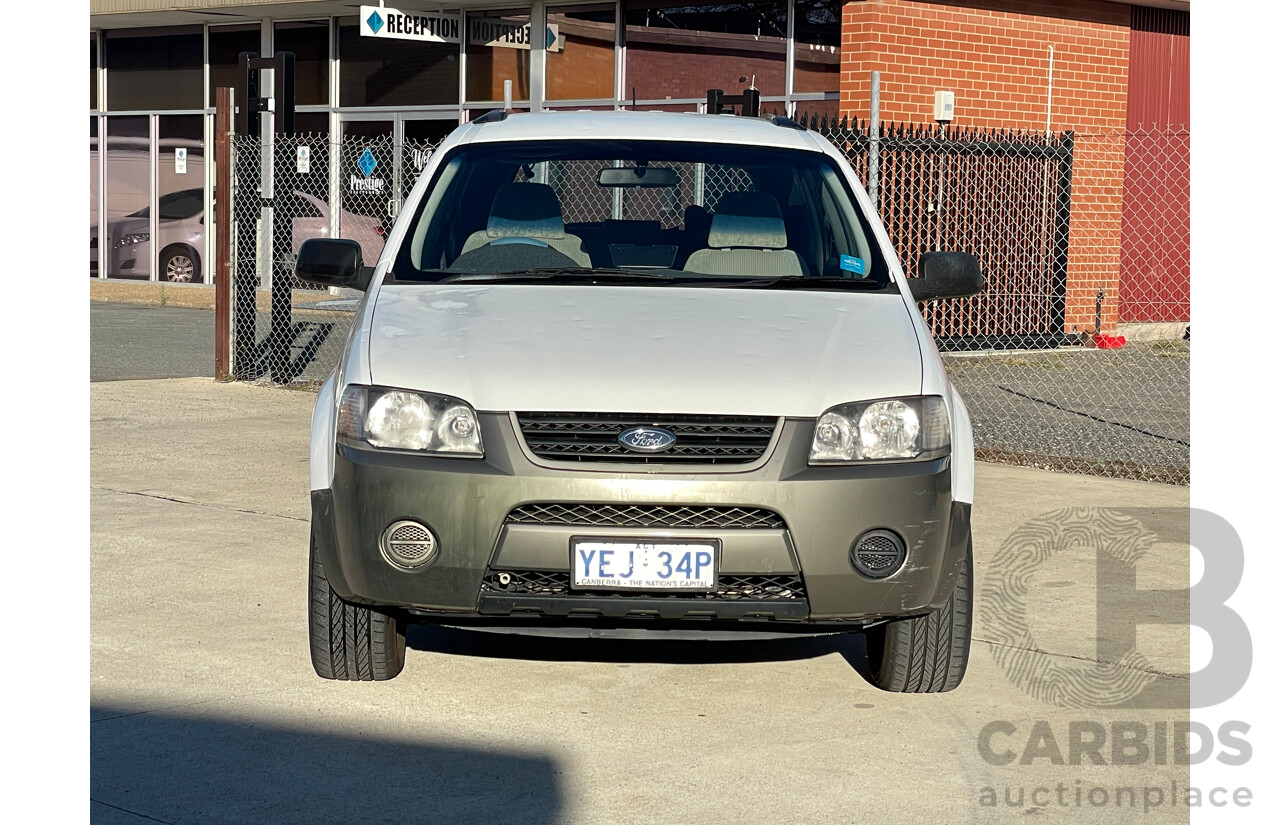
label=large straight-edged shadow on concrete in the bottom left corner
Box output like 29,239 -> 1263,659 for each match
90,703 -> 564,825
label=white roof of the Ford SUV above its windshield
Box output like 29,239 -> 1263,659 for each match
458,110 -> 822,151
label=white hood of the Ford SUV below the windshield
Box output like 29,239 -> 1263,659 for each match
367,284 -> 922,417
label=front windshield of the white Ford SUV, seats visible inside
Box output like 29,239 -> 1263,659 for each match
392,141 -> 888,289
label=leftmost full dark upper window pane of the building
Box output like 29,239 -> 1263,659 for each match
104,26 -> 205,111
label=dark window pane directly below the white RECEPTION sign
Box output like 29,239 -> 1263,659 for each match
340,18 -> 458,106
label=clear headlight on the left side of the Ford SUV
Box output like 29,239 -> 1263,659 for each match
338,386 -> 484,455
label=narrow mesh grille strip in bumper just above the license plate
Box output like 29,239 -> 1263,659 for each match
507,503 -> 786,530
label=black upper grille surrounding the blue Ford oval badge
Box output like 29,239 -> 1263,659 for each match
516,413 -> 778,464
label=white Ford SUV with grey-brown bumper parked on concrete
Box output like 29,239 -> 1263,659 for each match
297,111 -> 982,692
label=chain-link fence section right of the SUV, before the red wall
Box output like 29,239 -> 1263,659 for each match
788,114 -> 1190,483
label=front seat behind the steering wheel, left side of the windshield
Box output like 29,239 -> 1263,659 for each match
461,183 -> 591,267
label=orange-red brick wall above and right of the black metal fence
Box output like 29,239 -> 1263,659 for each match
841,0 -> 1129,333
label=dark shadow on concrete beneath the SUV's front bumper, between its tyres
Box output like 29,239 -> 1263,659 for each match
406,624 -> 869,678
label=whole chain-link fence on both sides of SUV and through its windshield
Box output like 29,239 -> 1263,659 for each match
233,118 -> 1190,483
